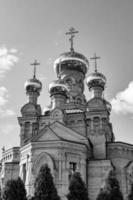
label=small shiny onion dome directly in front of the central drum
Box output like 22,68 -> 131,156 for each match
49,80 -> 68,96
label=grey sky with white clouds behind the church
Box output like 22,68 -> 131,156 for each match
0,0 -> 133,155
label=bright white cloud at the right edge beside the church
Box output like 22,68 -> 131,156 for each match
111,81 -> 133,114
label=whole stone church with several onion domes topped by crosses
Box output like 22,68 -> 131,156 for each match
0,28 -> 133,200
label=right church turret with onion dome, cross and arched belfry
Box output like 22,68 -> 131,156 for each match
86,54 -> 114,159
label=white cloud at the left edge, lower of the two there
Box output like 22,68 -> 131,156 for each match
0,86 -> 15,117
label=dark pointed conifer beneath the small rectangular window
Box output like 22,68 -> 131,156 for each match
67,172 -> 89,200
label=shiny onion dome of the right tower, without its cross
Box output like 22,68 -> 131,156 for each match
87,72 -> 106,88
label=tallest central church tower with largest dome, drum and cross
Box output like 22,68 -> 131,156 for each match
54,28 -> 89,108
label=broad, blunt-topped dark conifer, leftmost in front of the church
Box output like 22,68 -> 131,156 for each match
2,178 -> 26,200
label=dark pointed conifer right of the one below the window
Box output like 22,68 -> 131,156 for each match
97,171 -> 123,200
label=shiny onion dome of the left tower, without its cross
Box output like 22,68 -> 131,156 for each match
24,78 -> 42,92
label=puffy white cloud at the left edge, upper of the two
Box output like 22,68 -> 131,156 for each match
0,46 -> 18,78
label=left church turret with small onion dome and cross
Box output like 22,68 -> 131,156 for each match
18,60 -> 42,146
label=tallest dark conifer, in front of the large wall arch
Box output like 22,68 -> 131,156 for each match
34,164 -> 60,200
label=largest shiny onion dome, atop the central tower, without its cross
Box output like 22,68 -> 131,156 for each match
54,51 -> 89,75
